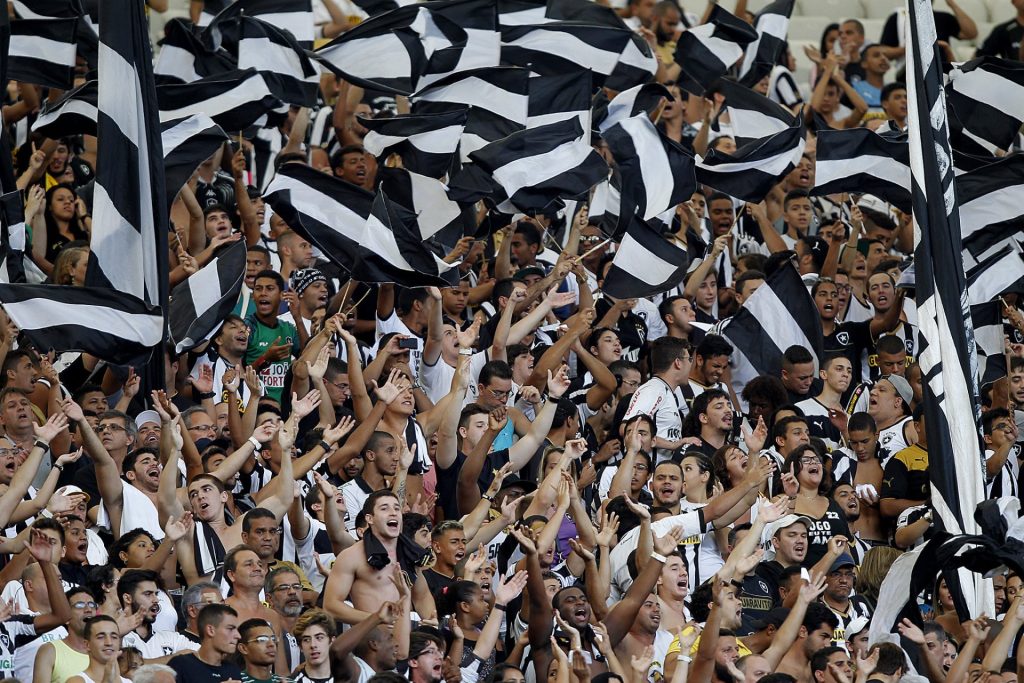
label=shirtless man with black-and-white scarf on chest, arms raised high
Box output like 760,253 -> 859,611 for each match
155,391 -> 311,584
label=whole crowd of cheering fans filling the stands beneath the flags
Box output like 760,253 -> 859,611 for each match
0,0 -> 1024,683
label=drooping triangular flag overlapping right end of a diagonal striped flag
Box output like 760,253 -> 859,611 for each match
352,190 -> 459,287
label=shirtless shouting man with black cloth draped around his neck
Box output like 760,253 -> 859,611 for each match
324,489 -> 436,625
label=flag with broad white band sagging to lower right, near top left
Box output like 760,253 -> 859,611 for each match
239,15 -> 319,106
